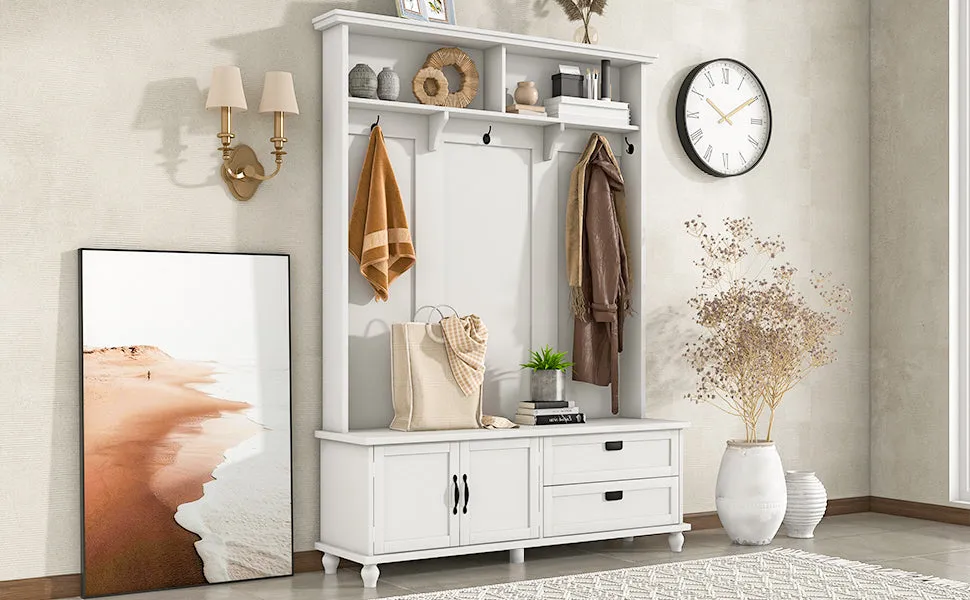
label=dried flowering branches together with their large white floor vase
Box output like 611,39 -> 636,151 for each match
684,215 -> 851,545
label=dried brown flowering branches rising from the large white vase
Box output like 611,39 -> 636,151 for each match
684,215 -> 852,442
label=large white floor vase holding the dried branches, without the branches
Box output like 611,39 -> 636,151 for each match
715,440 -> 788,546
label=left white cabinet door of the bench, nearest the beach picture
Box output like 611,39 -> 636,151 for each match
374,443 -> 461,554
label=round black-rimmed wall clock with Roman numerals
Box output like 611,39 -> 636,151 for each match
676,58 -> 771,177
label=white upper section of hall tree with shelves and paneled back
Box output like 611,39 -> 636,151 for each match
313,10 -> 656,439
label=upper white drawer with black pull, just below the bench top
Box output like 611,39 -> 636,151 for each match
542,431 -> 680,485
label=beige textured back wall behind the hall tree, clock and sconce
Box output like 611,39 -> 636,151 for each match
0,0 -> 868,580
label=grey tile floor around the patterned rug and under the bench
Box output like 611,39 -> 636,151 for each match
72,513 -> 970,600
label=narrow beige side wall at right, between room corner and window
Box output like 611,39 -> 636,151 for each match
870,0 -> 949,504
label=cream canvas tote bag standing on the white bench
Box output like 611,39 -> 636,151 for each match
390,306 -> 482,431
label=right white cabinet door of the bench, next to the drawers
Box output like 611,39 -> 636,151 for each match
459,439 -> 540,546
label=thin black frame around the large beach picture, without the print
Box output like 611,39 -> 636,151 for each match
77,247 -> 296,598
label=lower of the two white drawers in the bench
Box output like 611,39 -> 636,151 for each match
542,477 -> 680,537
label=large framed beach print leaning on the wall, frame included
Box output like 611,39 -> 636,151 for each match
78,249 -> 293,597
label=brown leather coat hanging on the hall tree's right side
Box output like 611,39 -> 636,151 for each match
573,137 -> 630,414
